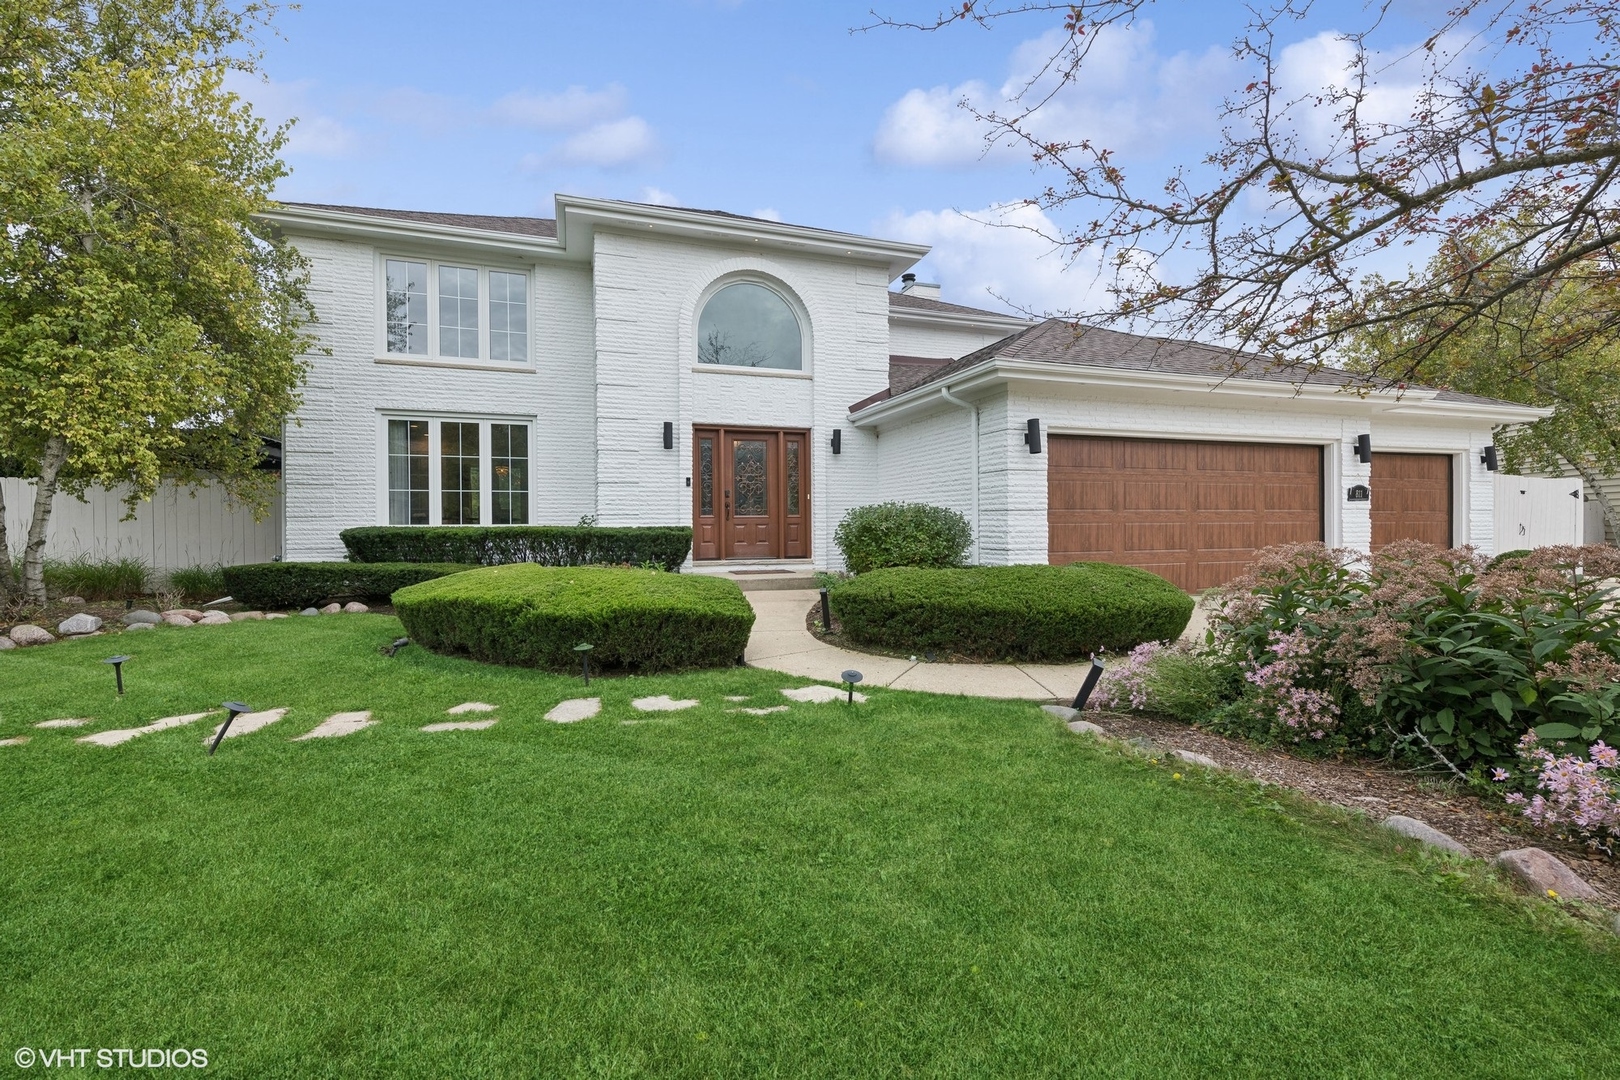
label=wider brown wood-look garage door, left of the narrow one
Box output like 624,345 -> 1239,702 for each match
1047,436 -> 1322,591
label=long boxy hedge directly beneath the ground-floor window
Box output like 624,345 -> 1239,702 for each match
337,525 -> 692,570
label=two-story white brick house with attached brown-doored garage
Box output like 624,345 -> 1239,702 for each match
269,196 -> 1541,588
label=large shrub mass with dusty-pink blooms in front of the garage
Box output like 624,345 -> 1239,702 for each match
1106,541 -> 1620,774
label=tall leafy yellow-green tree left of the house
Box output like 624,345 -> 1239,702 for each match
0,0 -> 313,601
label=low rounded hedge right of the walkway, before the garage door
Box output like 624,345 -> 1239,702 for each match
829,562 -> 1192,662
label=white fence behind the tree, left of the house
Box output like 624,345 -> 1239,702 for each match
0,478 -> 282,572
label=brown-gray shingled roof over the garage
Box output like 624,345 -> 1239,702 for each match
891,319 -> 1511,405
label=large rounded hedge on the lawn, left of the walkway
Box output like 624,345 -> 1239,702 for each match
394,563 -> 753,672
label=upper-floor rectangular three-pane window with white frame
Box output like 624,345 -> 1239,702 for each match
382,257 -> 528,363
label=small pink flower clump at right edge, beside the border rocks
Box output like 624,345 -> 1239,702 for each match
1492,732 -> 1620,855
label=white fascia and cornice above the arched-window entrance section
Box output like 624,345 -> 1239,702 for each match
557,194 -> 930,279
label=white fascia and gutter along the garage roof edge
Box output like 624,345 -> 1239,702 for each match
849,358 -> 1552,427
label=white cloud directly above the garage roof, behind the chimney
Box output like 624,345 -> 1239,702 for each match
876,202 -> 1106,314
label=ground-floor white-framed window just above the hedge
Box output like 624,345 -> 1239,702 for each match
384,416 -> 533,525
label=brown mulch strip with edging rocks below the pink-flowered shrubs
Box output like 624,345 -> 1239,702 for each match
1085,711 -> 1620,908
